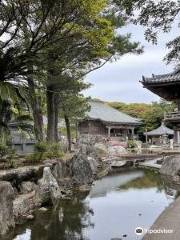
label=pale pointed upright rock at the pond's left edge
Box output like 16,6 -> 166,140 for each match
36,167 -> 61,204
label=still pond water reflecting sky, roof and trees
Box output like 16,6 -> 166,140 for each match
10,170 -> 176,240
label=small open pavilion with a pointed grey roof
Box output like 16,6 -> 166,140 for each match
144,121 -> 174,145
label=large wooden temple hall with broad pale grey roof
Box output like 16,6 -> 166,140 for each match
78,100 -> 141,141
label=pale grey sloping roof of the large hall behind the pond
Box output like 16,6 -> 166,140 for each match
87,100 -> 141,125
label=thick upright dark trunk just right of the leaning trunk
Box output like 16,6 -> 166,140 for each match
46,87 -> 55,143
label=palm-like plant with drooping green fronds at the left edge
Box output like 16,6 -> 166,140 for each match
0,82 -> 32,144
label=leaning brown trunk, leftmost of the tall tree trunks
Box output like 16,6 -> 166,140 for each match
28,77 -> 44,141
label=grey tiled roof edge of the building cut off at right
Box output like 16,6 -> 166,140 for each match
142,68 -> 180,84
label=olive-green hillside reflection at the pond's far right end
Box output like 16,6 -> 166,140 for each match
120,170 -> 163,191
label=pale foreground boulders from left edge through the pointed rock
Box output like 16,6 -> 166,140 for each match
0,167 -> 61,235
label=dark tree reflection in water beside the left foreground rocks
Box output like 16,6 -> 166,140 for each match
12,193 -> 93,240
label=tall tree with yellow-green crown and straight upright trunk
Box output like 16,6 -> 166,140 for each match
40,1 -> 140,142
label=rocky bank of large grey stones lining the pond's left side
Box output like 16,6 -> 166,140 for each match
0,148 -> 99,236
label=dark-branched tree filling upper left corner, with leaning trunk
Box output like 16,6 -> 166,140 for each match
0,0 -> 97,140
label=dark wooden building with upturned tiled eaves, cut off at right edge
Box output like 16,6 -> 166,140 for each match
142,69 -> 180,145
